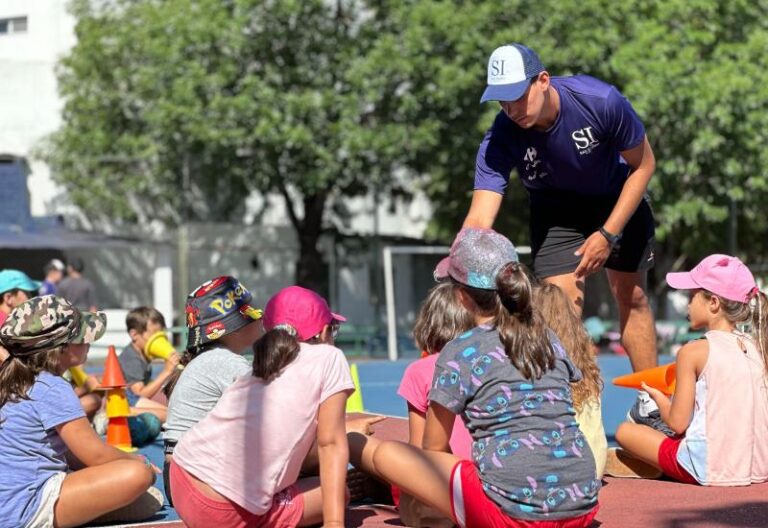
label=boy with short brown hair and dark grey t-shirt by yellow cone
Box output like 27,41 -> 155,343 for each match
117,306 -> 179,422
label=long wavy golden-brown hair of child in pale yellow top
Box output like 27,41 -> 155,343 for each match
533,282 -> 603,411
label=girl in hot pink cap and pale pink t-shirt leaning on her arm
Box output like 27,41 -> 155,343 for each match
170,286 -> 354,528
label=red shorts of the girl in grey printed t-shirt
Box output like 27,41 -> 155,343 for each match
451,460 -> 599,528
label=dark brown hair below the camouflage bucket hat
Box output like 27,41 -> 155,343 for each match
0,345 -> 66,408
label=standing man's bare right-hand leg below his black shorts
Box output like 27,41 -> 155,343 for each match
606,270 -> 657,372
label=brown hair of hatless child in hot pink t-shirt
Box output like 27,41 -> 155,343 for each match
413,282 -> 475,354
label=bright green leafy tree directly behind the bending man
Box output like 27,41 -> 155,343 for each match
360,0 -> 768,282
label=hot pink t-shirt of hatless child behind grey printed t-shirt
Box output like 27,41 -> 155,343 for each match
397,354 -> 472,460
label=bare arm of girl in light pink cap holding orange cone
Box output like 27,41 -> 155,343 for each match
643,339 -> 709,434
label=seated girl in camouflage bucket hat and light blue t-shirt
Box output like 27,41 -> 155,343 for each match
0,295 -> 162,526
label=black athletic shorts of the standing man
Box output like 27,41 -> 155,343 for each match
530,193 -> 656,279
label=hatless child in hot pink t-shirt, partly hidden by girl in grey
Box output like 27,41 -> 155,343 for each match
397,281 -> 475,528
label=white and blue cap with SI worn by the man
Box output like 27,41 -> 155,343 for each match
480,43 -> 544,103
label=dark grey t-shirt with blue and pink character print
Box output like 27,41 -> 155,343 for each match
429,326 -> 600,521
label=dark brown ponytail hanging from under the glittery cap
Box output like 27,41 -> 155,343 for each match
452,262 -> 555,380
